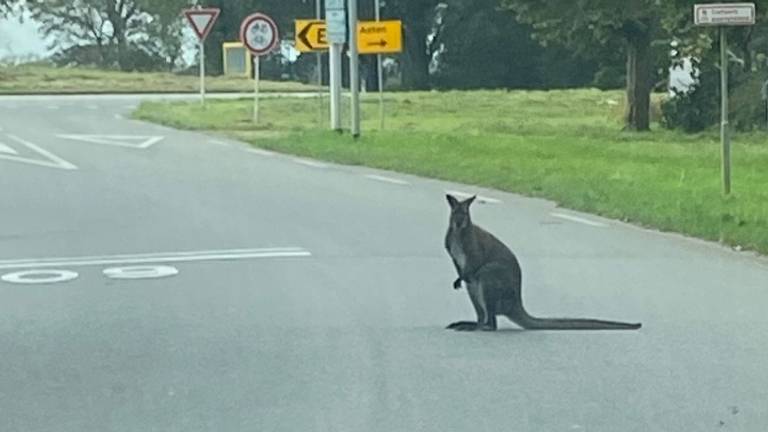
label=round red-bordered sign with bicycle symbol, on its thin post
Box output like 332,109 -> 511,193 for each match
240,12 -> 279,124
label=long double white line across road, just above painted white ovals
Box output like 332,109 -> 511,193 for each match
0,247 -> 312,269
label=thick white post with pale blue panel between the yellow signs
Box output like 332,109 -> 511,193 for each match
325,0 -> 347,132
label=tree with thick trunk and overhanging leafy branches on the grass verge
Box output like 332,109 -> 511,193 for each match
502,0 -> 662,131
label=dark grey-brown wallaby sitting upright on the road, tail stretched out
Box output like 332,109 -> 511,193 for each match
445,195 -> 641,331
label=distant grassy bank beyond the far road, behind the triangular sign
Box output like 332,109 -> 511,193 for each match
0,64 -> 314,94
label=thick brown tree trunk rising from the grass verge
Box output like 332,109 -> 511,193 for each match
624,30 -> 653,131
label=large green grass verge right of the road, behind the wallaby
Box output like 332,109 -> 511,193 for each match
135,90 -> 768,253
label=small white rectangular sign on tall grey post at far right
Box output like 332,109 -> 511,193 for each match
693,3 -> 755,195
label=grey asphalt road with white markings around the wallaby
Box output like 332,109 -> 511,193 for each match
0,96 -> 768,432
